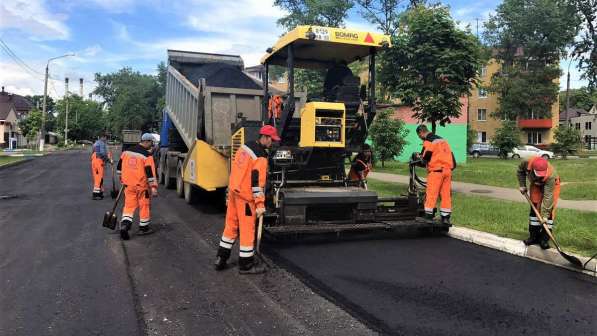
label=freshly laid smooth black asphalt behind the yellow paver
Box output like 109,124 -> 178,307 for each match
271,237 -> 597,335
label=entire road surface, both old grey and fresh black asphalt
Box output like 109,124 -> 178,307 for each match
0,151 -> 597,336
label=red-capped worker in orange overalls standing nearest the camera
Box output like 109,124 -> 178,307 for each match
215,125 -> 280,274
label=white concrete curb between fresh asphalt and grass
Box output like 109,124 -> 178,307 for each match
448,226 -> 597,277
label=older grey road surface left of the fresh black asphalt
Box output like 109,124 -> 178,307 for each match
0,151 -> 375,336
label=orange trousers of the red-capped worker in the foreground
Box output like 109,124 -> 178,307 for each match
222,193 -> 256,258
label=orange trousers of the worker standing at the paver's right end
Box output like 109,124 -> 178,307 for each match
425,169 -> 452,214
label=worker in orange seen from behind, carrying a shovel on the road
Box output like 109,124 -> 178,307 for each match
116,133 -> 158,240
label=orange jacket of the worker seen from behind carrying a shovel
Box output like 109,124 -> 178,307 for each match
116,145 -> 158,188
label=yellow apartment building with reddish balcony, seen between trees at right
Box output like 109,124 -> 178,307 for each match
469,60 -> 559,147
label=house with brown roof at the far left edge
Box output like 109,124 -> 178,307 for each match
0,87 -> 33,148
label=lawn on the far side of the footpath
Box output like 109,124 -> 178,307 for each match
375,158 -> 597,200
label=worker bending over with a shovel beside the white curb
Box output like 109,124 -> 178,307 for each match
517,157 -> 560,249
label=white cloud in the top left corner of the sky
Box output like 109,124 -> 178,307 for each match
0,0 -> 70,40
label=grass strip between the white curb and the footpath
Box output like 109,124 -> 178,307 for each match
368,179 -> 597,256
